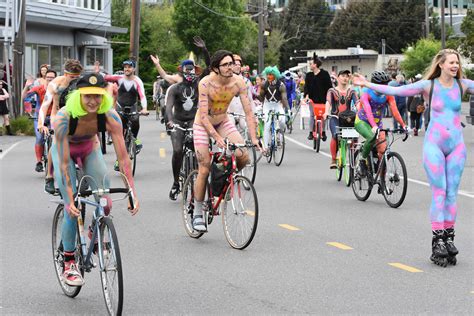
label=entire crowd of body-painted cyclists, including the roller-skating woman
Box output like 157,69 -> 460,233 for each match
6,43 -> 474,286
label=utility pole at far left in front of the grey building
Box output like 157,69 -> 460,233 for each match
12,0 -> 26,117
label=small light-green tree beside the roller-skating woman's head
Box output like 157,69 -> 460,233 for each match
401,38 -> 441,78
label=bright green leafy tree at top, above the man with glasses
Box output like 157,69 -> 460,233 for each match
173,0 -> 254,55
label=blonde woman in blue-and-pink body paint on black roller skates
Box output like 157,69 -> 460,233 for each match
354,49 -> 474,266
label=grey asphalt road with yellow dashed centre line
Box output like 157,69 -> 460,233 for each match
0,112 -> 474,315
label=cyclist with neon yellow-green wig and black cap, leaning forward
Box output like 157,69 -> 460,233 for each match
51,73 -> 139,286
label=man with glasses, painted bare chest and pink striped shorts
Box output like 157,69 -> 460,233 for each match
193,50 -> 258,232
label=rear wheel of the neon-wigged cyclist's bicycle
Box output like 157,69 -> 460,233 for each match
52,204 -> 84,297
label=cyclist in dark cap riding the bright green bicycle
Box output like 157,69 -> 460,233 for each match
323,70 -> 357,169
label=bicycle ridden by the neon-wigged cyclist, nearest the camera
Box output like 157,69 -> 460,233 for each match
52,175 -> 134,315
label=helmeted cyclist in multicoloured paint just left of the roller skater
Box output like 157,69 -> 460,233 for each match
355,71 -> 406,176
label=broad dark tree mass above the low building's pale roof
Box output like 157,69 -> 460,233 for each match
330,0 -> 425,53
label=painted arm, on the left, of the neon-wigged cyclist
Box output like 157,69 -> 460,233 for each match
54,109 -> 79,216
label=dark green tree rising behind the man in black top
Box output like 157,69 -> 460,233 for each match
278,0 -> 334,69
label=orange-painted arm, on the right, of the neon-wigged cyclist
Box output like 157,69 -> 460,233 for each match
105,110 -> 140,215
